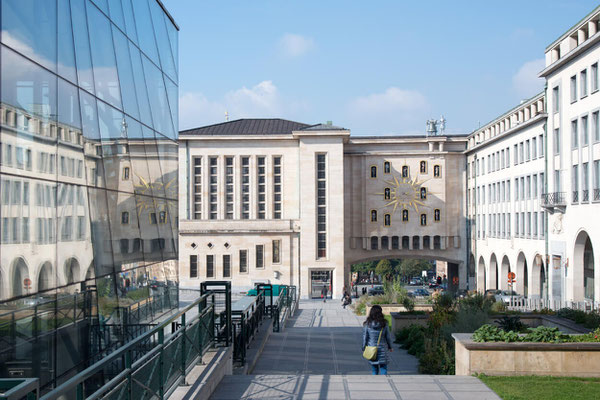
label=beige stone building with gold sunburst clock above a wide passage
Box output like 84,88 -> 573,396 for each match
179,119 -> 467,298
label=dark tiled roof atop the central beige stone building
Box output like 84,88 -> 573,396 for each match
179,118 -> 311,136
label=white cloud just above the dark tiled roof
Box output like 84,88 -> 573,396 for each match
179,80 -> 307,129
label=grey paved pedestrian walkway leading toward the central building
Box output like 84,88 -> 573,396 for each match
212,300 -> 500,400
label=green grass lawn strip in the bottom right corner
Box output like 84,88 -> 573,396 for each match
478,375 -> 600,400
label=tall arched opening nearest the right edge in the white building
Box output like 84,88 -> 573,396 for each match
573,231 -> 596,301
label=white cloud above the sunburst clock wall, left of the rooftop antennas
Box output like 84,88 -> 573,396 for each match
347,86 -> 430,135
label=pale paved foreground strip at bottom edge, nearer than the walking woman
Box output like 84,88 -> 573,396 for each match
211,374 -> 500,400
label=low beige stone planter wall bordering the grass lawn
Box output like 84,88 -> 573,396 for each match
452,333 -> 600,377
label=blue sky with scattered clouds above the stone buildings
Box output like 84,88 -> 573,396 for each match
162,0 -> 598,136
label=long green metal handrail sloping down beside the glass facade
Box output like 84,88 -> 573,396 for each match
40,292 -> 213,400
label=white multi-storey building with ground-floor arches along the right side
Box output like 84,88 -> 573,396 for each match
466,7 -> 600,304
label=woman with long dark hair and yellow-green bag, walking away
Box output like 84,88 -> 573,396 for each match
362,305 -> 394,375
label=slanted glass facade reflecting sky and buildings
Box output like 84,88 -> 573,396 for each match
0,0 -> 178,387
